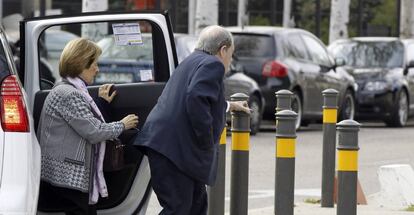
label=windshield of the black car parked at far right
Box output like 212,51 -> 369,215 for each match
331,41 -> 404,68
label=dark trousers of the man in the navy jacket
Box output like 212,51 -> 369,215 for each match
146,149 -> 207,215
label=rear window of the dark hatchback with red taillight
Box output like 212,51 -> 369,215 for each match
233,33 -> 276,58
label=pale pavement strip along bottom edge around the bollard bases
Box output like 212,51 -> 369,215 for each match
244,203 -> 414,215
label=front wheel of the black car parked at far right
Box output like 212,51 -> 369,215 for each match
385,89 -> 408,127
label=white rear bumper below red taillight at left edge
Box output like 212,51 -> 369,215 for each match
0,132 -> 41,215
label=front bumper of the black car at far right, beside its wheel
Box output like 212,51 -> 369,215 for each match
356,91 -> 395,119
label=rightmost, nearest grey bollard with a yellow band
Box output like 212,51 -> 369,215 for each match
336,120 -> 361,215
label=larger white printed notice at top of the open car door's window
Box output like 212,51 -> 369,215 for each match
112,23 -> 143,46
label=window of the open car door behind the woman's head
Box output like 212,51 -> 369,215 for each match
39,21 -> 155,89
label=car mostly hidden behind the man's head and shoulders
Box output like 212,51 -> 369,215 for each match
174,34 -> 265,134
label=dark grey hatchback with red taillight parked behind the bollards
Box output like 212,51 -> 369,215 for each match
228,26 -> 356,128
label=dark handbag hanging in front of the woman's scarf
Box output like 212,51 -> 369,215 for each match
103,138 -> 125,172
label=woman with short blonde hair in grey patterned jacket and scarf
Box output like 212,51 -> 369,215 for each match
38,38 -> 138,214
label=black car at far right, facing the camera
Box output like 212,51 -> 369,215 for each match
329,37 -> 414,127
